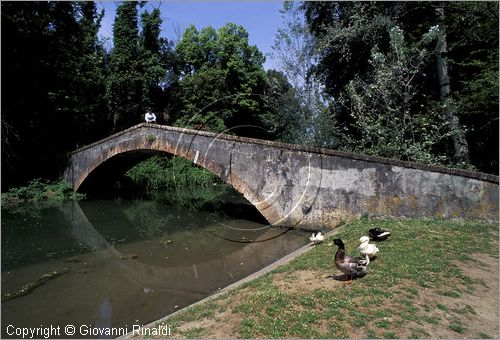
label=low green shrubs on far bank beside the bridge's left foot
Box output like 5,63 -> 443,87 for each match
2,178 -> 84,209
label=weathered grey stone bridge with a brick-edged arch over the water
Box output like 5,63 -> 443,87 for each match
64,123 -> 499,230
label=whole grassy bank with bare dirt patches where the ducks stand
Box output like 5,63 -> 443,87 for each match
133,220 -> 498,338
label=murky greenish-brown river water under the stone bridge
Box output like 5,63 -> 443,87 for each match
1,190 -> 307,338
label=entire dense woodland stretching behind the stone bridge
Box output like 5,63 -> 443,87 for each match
1,1 -> 499,191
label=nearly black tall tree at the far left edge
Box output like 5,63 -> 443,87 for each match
1,2 -> 51,190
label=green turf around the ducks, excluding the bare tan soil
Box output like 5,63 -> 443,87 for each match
144,219 -> 498,338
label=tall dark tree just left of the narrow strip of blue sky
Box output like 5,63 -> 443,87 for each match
49,2 -> 109,147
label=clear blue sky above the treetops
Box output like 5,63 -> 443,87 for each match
97,0 -> 283,70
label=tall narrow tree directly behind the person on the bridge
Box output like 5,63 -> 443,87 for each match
106,1 -> 168,131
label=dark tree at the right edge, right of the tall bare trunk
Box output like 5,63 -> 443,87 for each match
441,1 -> 499,174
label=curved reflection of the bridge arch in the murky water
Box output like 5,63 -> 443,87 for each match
62,202 -> 303,298
